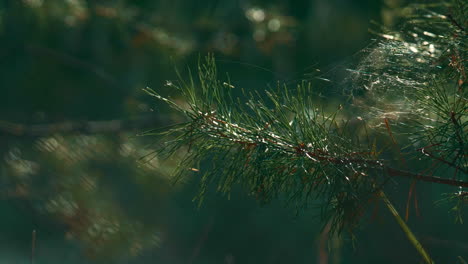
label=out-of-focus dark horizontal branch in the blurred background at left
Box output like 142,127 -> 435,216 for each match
0,116 -> 169,137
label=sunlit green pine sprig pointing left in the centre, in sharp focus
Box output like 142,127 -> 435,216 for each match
146,56 -> 383,230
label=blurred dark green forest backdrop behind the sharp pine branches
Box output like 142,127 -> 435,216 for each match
0,0 -> 468,264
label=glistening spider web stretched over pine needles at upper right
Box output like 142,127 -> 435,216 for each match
342,5 -> 464,132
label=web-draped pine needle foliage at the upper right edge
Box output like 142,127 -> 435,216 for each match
348,1 -> 468,178
